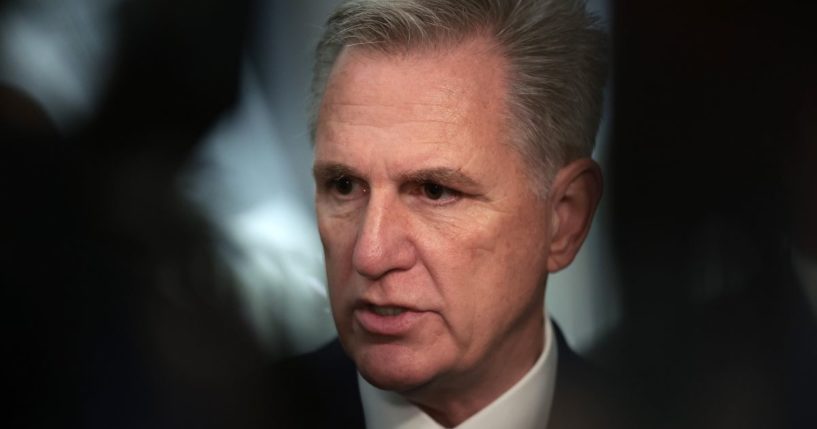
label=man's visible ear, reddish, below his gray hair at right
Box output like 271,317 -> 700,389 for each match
547,158 -> 602,273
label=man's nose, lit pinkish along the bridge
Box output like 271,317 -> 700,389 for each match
352,191 -> 417,280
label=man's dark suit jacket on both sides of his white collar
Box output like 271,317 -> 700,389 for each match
276,322 -> 634,429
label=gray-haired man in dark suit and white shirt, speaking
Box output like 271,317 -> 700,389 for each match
272,0 -> 612,428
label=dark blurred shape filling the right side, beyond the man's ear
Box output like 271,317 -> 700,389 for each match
610,0 -> 817,428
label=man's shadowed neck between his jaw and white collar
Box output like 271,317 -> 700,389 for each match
403,315 -> 545,428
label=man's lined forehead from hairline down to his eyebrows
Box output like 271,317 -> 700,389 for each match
316,38 -> 506,155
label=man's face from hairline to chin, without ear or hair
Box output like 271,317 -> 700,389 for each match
315,41 -> 550,392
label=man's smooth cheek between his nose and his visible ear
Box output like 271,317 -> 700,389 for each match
433,206 -> 547,336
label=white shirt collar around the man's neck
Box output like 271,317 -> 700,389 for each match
358,317 -> 558,429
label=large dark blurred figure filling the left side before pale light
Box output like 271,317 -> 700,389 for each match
0,0 -> 286,428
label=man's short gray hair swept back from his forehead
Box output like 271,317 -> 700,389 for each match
310,0 -> 607,191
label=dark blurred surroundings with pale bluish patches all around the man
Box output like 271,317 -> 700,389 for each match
0,0 -> 817,428
